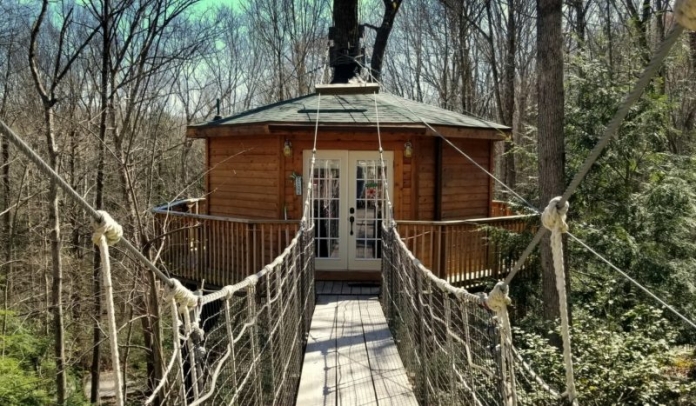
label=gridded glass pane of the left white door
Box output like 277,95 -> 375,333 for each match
312,159 -> 341,258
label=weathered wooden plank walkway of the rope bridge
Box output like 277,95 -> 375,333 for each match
296,282 -> 418,406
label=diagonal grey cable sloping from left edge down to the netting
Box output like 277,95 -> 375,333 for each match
0,120 -> 172,286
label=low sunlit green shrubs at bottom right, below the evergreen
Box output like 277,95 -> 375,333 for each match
516,305 -> 696,406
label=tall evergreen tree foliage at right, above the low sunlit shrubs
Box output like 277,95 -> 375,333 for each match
566,49 -> 696,343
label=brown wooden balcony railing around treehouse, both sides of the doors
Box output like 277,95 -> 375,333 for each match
153,200 -> 530,287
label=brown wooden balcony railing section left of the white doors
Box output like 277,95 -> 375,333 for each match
153,205 -> 299,286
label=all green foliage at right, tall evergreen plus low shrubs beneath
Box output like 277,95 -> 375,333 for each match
511,44 -> 696,405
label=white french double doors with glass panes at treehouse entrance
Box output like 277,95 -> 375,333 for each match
304,151 -> 393,271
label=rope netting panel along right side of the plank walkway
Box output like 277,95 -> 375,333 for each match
381,227 -> 560,406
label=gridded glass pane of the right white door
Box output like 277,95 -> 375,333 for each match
354,159 -> 386,259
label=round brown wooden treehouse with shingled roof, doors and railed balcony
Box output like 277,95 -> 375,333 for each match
155,84 -> 524,286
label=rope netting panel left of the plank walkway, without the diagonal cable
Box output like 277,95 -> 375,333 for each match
146,227 -> 314,406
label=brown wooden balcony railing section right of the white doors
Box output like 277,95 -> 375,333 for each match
397,216 -> 530,287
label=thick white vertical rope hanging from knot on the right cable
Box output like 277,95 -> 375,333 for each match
541,196 -> 577,405
